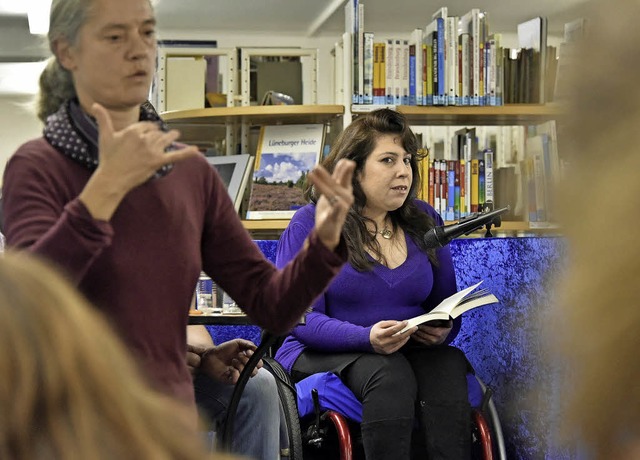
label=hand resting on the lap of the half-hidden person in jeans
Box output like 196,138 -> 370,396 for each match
200,339 -> 262,385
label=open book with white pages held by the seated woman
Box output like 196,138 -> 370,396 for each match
398,281 -> 500,334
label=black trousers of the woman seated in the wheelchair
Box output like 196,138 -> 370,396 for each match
292,345 -> 472,460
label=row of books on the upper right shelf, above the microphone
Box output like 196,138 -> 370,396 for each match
343,0 -> 555,106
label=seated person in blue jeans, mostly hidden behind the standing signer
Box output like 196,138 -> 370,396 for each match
187,326 -> 280,459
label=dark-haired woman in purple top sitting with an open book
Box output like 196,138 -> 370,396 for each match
276,109 -> 470,460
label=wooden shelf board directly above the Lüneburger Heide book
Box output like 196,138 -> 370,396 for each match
162,105 -> 344,126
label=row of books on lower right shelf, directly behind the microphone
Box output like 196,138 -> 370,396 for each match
419,121 -> 566,223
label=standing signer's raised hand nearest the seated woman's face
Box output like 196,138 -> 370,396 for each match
308,159 -> 356,250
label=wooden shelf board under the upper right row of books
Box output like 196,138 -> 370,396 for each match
351,104 -> 563,126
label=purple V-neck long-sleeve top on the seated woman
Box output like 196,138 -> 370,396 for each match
276,200 -> 460,371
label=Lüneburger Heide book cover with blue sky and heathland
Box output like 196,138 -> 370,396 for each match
247,124 -> 324,219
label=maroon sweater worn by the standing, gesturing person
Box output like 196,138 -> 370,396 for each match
3,138 -> 346,402
